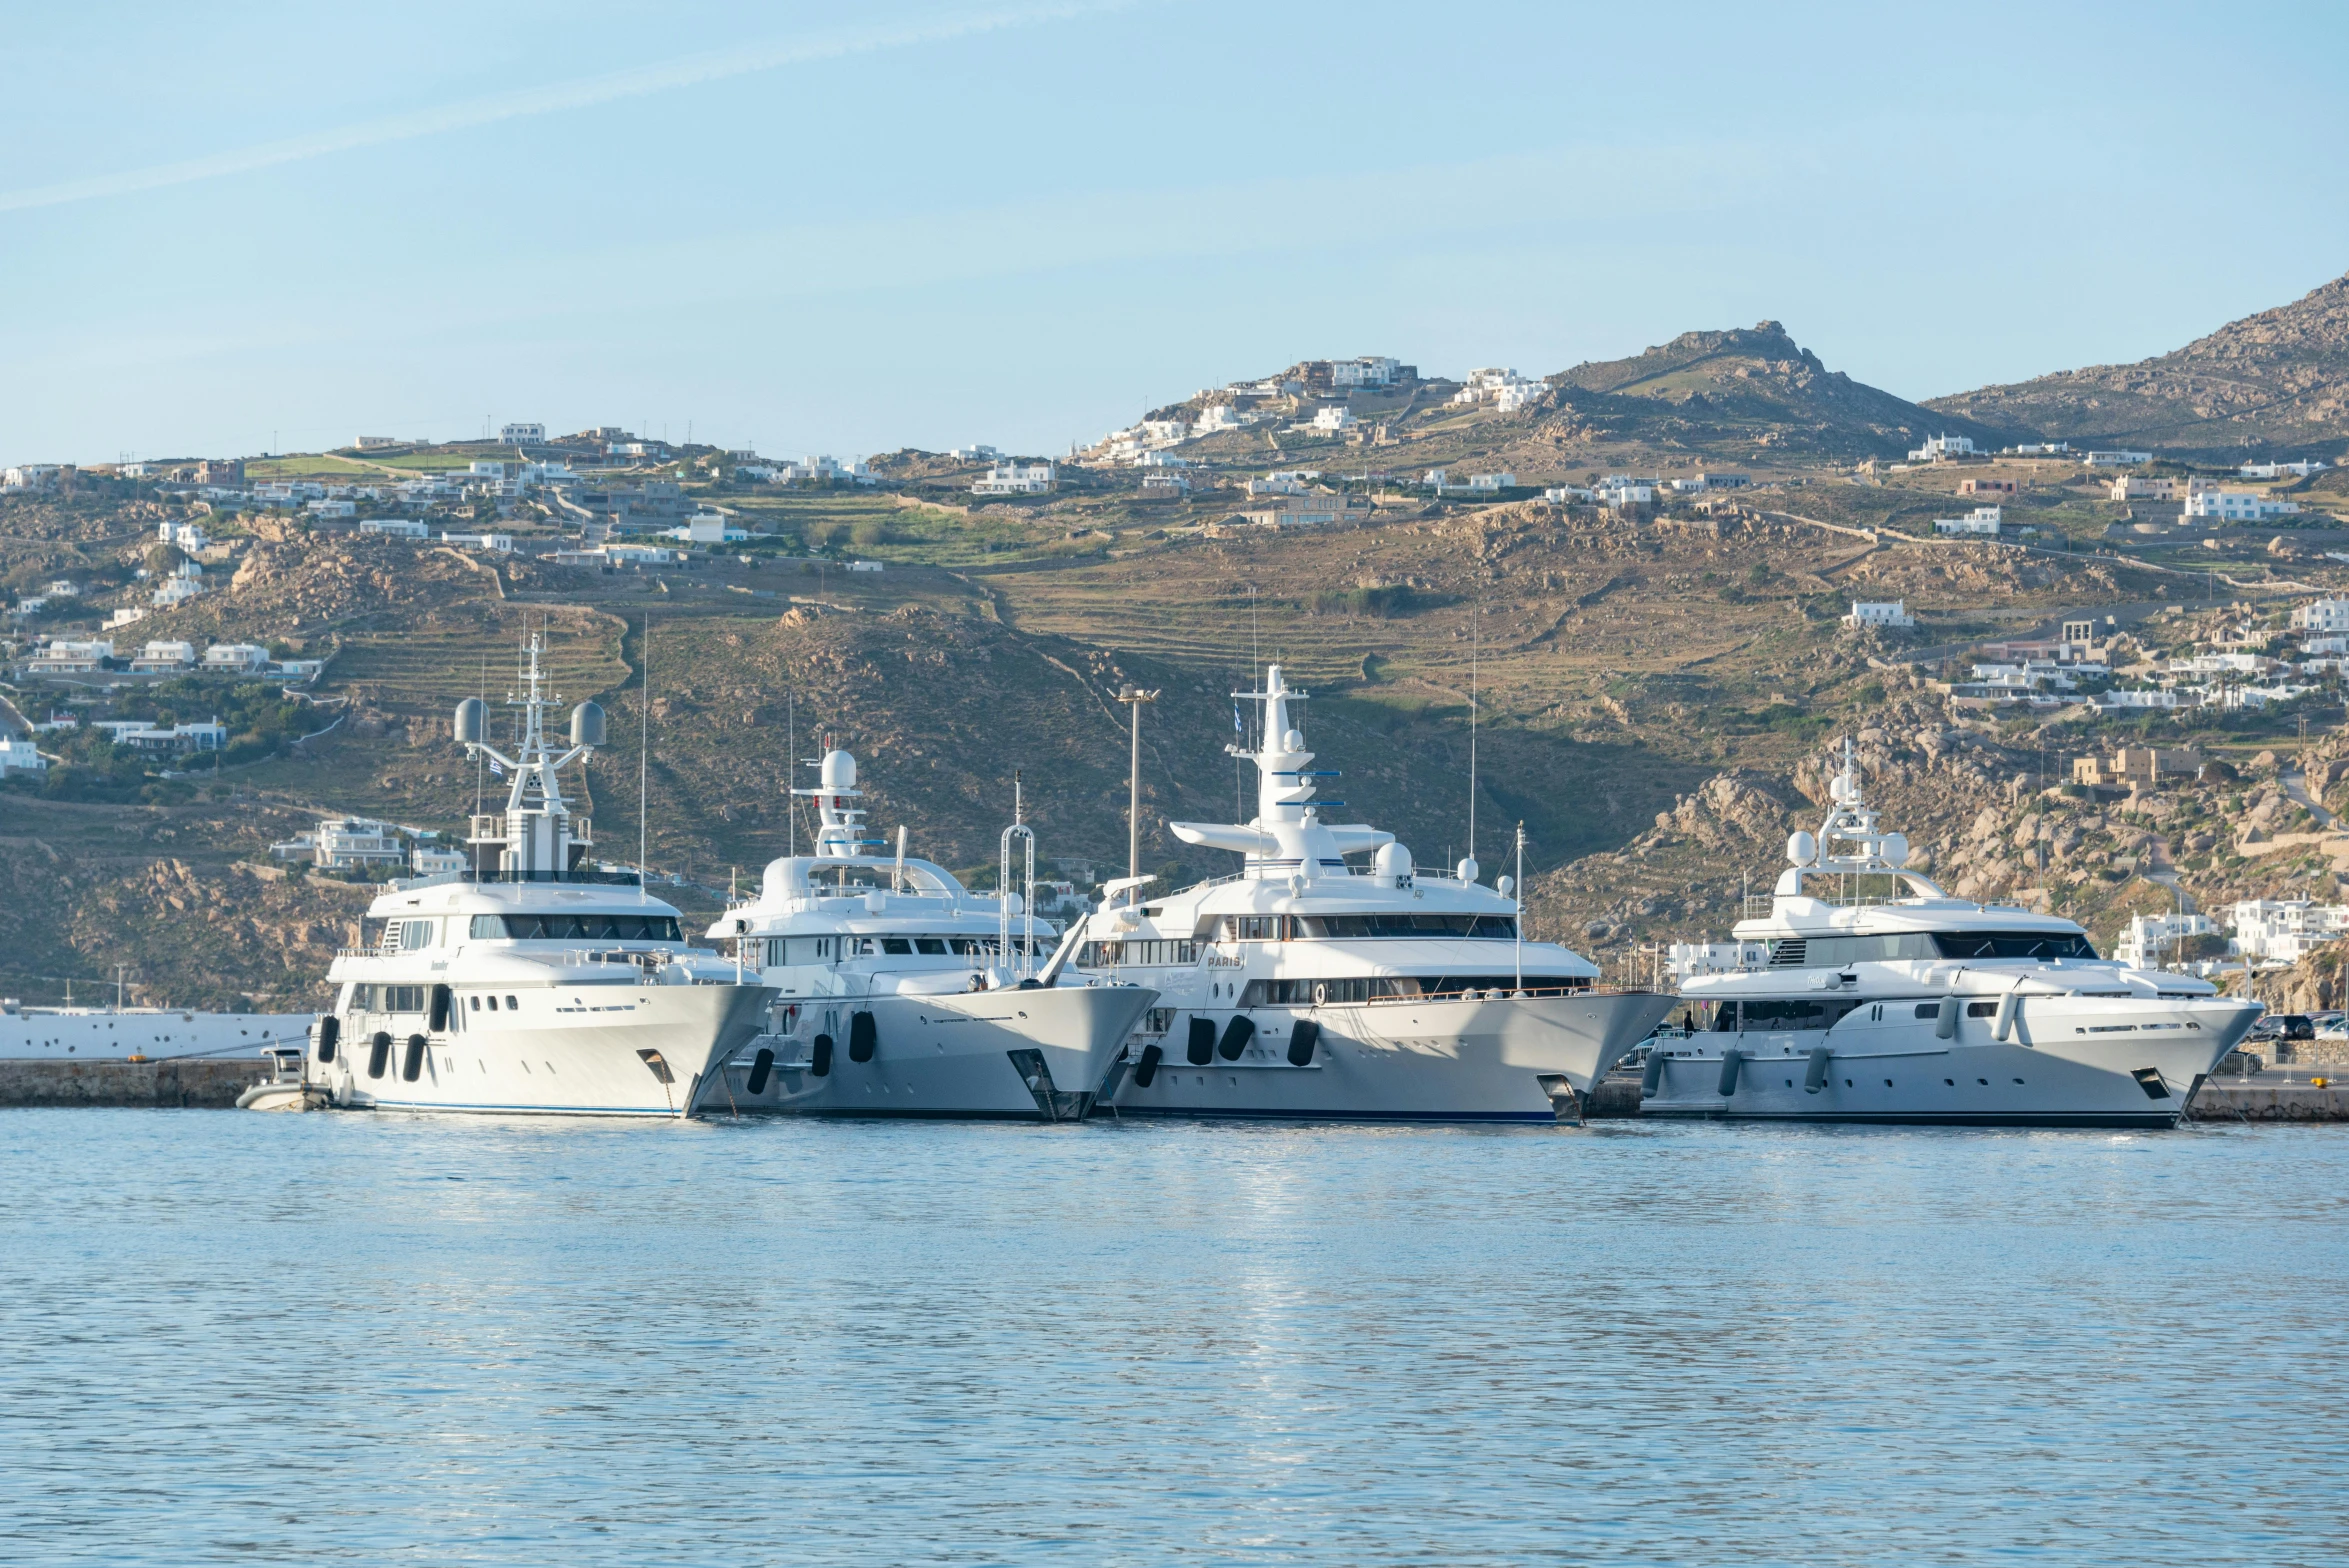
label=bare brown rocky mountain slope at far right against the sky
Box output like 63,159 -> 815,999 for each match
1924,266 -> 2349,460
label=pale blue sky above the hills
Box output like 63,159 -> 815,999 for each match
0,0 -> 2349,462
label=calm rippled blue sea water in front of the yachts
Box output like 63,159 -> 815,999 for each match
0,1110 -> 2349,1563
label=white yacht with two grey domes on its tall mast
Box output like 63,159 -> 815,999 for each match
308,636 -> 773,1117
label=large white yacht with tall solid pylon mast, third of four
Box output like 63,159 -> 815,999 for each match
1078,664 -> 1672,1122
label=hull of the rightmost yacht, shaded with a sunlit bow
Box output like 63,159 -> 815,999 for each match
1640,995 -> 2260,1127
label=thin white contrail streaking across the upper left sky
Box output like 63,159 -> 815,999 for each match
0,0 -> 1132,211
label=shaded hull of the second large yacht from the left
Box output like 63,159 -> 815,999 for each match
712,986 -> 1158,1122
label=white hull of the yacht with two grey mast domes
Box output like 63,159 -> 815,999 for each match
326,986 -> 775,1117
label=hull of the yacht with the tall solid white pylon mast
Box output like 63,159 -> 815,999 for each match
1116,991 -> 1672,1122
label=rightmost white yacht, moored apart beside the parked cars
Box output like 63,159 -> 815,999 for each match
1642,742 -> 2260,1127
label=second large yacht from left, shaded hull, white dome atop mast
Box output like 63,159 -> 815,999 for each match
709,749 -> 1158,1122
